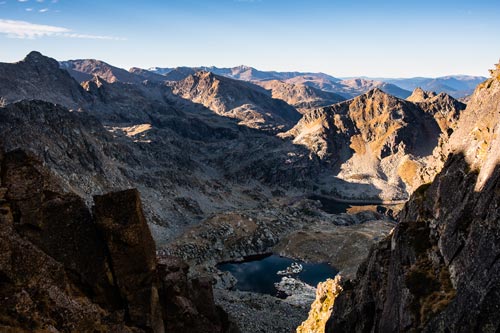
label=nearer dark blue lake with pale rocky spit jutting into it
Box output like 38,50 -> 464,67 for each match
217,255 -> 338,296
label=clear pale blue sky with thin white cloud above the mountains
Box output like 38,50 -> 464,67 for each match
0,0 -> 500,77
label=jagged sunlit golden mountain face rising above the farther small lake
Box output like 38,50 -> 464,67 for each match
283,89 -> 459,200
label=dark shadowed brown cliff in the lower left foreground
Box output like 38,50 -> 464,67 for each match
0,151 -> 235,332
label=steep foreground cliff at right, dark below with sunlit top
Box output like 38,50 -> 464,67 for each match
327,62 -> 500,332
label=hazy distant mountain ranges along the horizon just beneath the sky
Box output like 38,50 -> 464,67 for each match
60,59 -> 486,101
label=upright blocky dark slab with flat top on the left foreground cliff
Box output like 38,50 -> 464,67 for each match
94,190 -> 164,332
